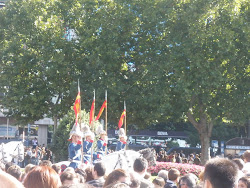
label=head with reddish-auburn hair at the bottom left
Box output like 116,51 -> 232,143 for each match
23,166 -> 61,188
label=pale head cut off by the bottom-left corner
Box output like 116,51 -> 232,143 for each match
0,170 -> 24,188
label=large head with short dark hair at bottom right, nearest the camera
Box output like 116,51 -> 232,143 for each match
204,158 -> 239,188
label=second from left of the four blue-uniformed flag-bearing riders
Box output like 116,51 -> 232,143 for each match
83,130 -> 94,164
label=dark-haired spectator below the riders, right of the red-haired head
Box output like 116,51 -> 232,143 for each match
87,162 -> 106,188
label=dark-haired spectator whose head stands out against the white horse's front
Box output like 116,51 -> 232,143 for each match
133,158 -> 154,188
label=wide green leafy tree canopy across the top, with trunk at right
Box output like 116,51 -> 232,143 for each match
0,0 -> 250,162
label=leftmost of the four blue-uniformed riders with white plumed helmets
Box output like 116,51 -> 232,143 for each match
68,125 -> 82,169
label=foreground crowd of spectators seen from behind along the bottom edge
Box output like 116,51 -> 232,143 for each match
0,150 -> 250,188
